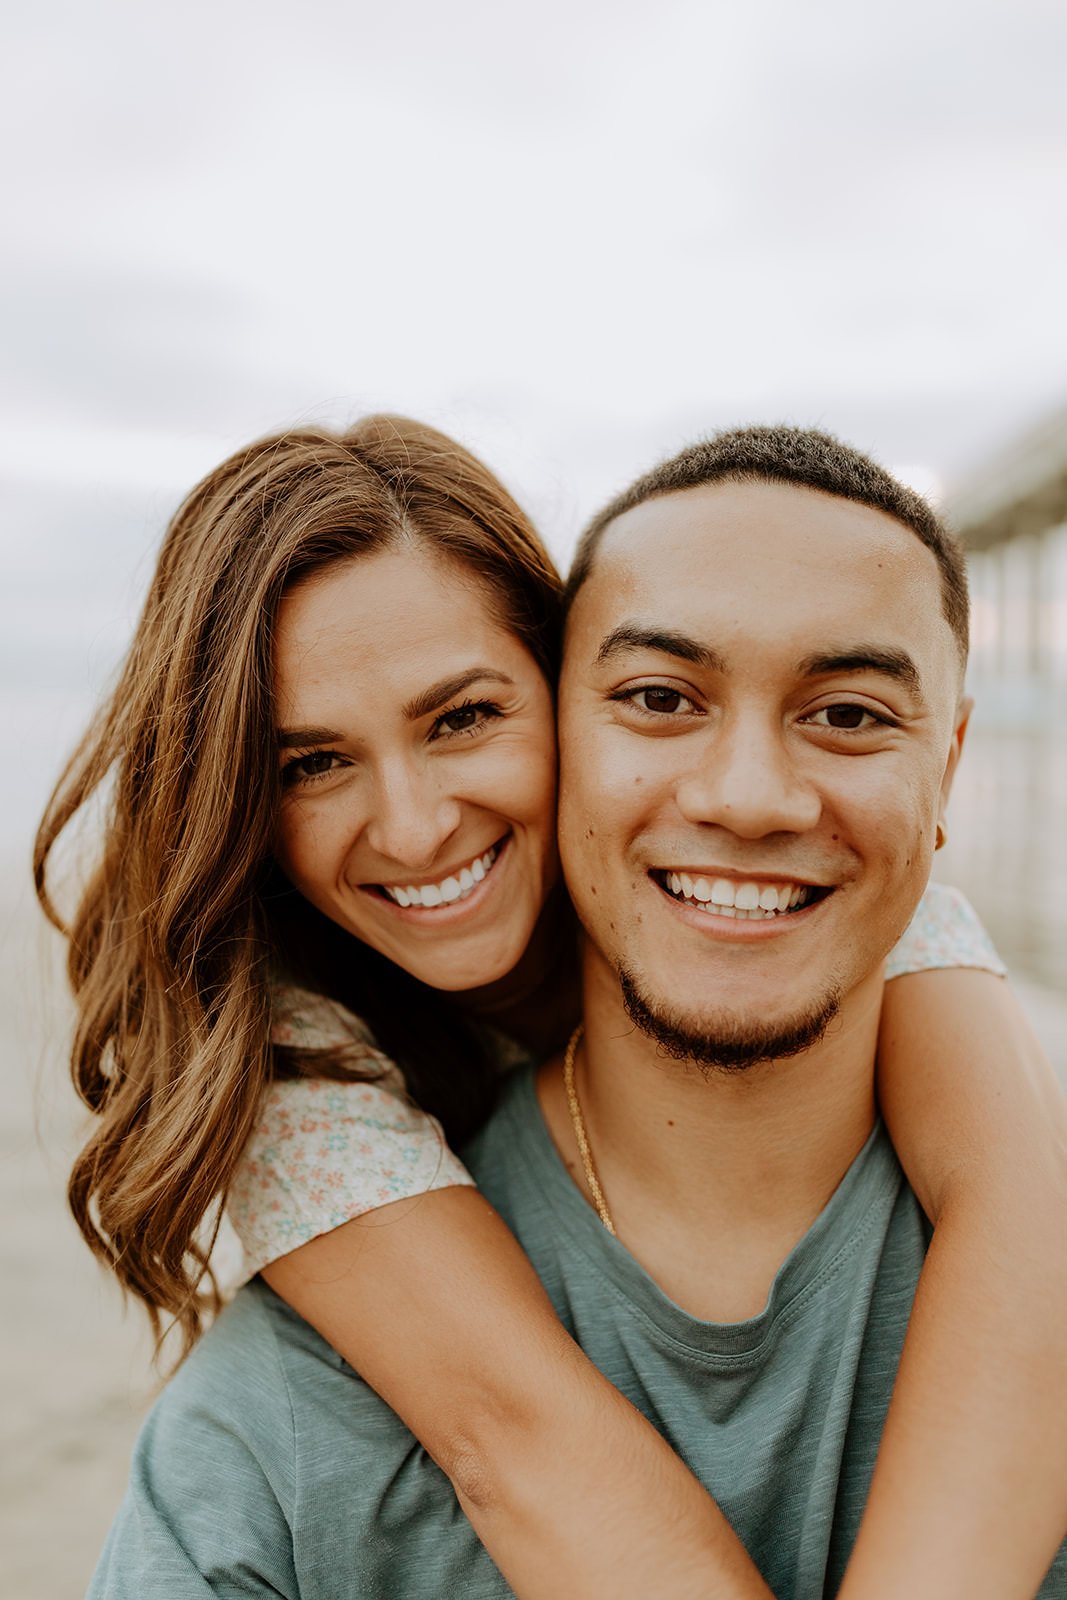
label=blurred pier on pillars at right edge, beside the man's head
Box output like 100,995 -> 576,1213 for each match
937,410 -> 1067,1082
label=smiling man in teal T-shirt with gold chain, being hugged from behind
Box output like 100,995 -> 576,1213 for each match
89,429 -> 1067,1600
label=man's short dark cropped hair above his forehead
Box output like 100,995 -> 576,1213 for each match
565,427 -> 969,662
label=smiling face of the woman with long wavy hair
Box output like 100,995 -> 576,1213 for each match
274,546 -> 558,990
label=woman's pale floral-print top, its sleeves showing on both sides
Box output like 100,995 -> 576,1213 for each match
227,883 -> 1005,1278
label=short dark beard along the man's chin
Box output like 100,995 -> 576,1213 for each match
619,970 -> 841,1072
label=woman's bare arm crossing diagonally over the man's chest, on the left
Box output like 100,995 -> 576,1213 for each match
262,1187 -> 771,1600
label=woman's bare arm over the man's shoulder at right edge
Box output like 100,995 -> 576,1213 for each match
840,970 -> 1067,1600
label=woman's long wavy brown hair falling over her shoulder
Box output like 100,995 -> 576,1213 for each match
34,416 -> 560,1354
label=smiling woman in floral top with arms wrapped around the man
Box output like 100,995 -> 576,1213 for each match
37,418 -> 1061,1597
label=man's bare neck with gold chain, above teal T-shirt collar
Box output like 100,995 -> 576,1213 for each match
539,970 -> 881,1322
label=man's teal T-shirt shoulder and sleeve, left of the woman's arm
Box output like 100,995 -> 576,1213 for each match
116,1280 -> 504,1600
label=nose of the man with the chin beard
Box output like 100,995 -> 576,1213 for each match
675,715 -> 822,838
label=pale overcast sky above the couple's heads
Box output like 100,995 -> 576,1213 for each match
0,0 -> 1067,566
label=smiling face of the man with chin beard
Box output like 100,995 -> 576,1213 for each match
560,483 -> 965,1064
